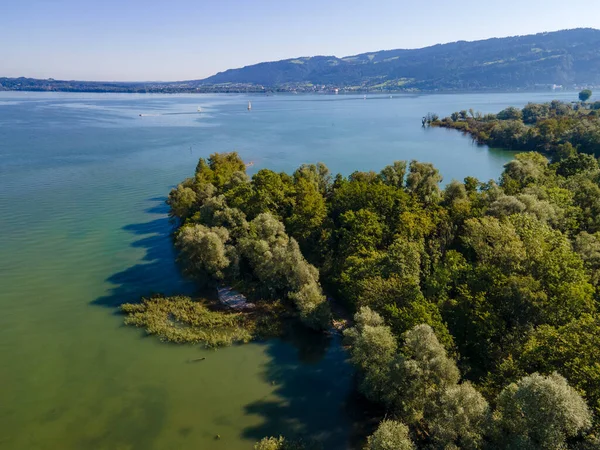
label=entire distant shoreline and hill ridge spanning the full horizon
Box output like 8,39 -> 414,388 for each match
0,28 -> 600,93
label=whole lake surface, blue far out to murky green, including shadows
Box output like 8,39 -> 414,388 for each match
0,92 -> 574,450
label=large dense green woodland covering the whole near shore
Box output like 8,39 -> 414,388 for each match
168,151 -> 600,449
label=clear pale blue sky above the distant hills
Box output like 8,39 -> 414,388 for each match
0,0 -> 600,81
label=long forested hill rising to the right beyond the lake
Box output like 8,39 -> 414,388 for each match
202,29 -> 600,90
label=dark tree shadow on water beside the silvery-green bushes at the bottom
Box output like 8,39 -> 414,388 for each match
243,330 -> 353,450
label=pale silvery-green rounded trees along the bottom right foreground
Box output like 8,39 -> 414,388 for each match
345,308 -> 600,450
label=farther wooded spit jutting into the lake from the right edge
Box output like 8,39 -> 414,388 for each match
424,100 -> 600,158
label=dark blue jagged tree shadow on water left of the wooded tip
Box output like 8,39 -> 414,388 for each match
92,197 -> 194,308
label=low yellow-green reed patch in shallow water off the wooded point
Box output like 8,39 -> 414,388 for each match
121,296 -> 282,348
